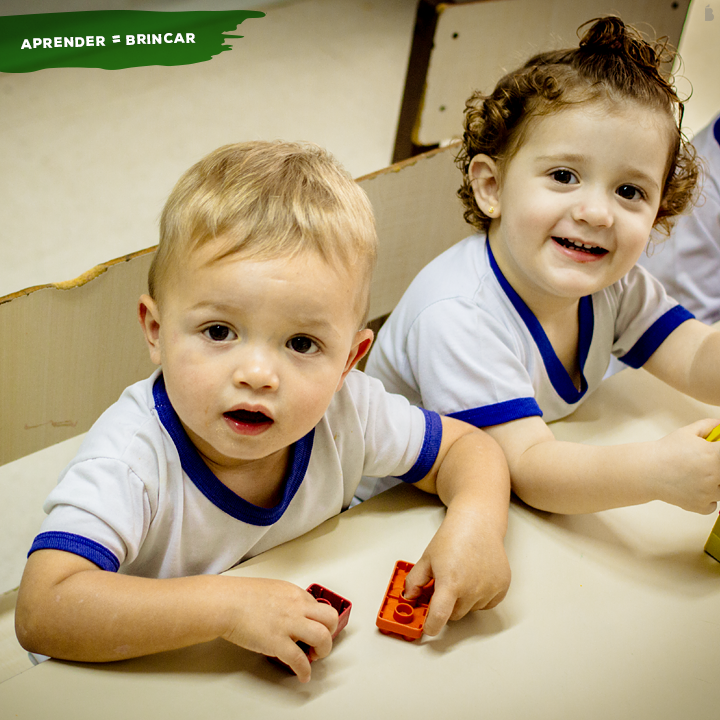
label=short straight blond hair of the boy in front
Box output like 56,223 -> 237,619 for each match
148,141 -> 377,320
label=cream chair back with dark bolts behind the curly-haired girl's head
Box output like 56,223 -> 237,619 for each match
420,0 -> 690,146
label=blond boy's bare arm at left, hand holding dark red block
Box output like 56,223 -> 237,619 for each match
15,550 -> 338,682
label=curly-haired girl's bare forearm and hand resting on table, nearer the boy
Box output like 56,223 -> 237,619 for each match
487,410 -> 720,514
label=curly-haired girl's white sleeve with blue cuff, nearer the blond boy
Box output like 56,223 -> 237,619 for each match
407,298 -> 541,427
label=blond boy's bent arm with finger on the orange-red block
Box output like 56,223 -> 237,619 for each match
405,418 -> 510,635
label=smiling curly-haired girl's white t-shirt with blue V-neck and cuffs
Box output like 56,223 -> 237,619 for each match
366,235 -> 692,427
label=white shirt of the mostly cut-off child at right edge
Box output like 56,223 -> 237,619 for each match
640,115 -> 720,323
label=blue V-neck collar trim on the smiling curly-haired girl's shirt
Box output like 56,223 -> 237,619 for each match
485,237 -> 595,405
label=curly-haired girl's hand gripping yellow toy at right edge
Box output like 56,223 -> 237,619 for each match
649,420 -> 720,515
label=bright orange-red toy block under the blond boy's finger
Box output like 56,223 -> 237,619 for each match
376,560 -> 435,642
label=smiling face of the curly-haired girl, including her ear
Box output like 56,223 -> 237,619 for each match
470,103 -> 670,306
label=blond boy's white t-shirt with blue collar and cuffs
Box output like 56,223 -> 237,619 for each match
30,371 -> 442,578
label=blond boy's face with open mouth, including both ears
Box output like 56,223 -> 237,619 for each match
140,247 -> 372,470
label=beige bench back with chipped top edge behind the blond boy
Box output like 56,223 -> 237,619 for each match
0,147 -> 470,464
